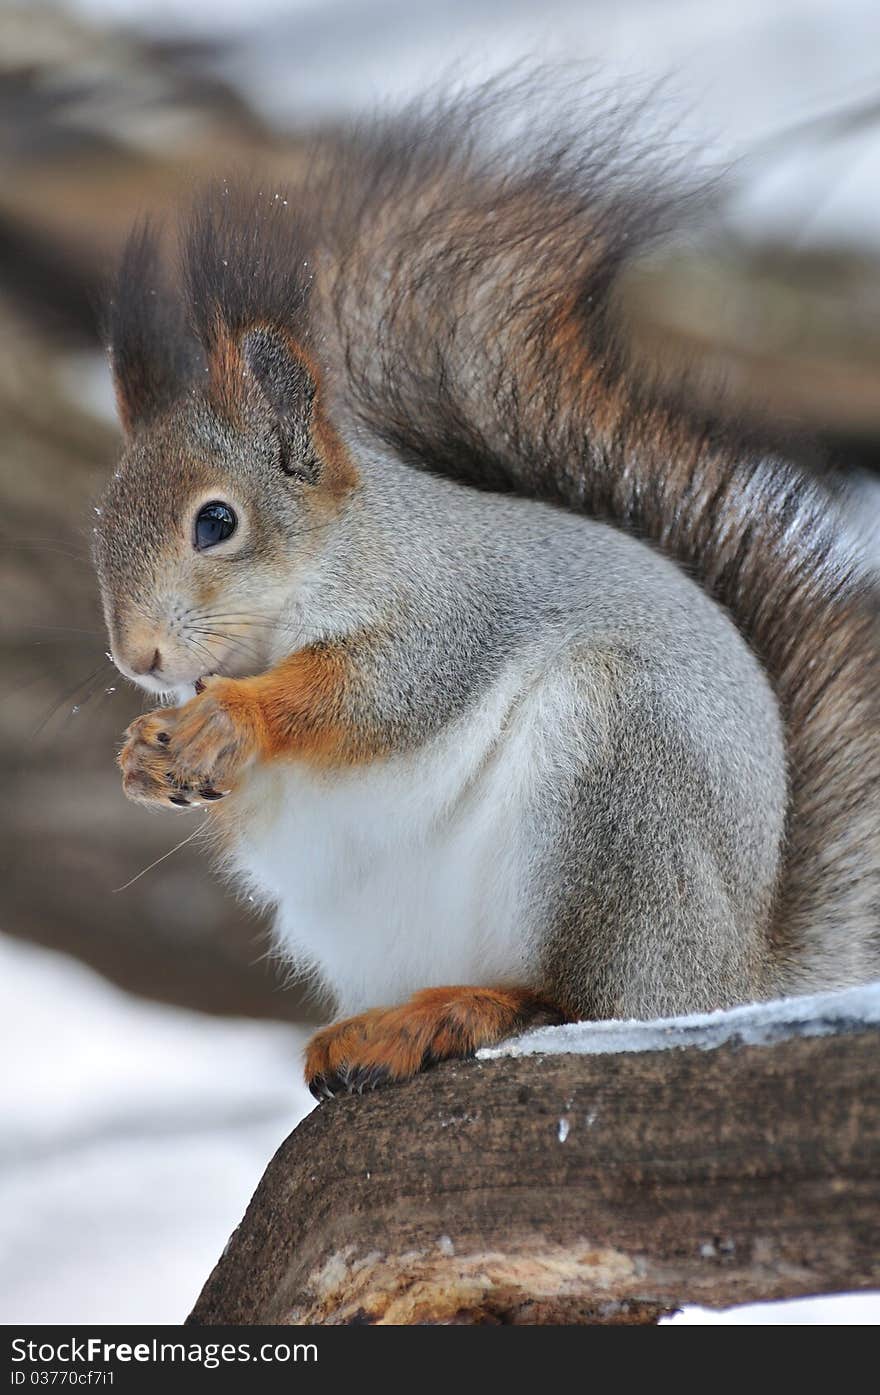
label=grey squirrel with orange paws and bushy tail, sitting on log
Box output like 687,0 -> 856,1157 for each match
95,87 -> 880,1098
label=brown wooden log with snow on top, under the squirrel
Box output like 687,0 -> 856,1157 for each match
190,985 -> 880,1324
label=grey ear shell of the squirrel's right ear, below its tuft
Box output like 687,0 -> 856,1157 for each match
241,326 -> 322,484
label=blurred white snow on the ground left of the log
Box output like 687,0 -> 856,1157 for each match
0,937 -> 314,1324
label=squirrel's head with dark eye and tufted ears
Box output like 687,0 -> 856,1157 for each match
95,209 -> 356,696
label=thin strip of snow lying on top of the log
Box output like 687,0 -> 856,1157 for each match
478,982 -> 880,1060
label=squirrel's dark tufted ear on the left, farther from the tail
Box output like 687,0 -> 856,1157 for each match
105,223 -> 204,435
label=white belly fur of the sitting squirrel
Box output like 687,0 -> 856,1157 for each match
225,658 -> 570,1013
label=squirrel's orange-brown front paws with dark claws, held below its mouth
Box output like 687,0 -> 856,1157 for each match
119,678 -> 258,808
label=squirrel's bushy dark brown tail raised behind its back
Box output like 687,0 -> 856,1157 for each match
305,92 -> 880,989
